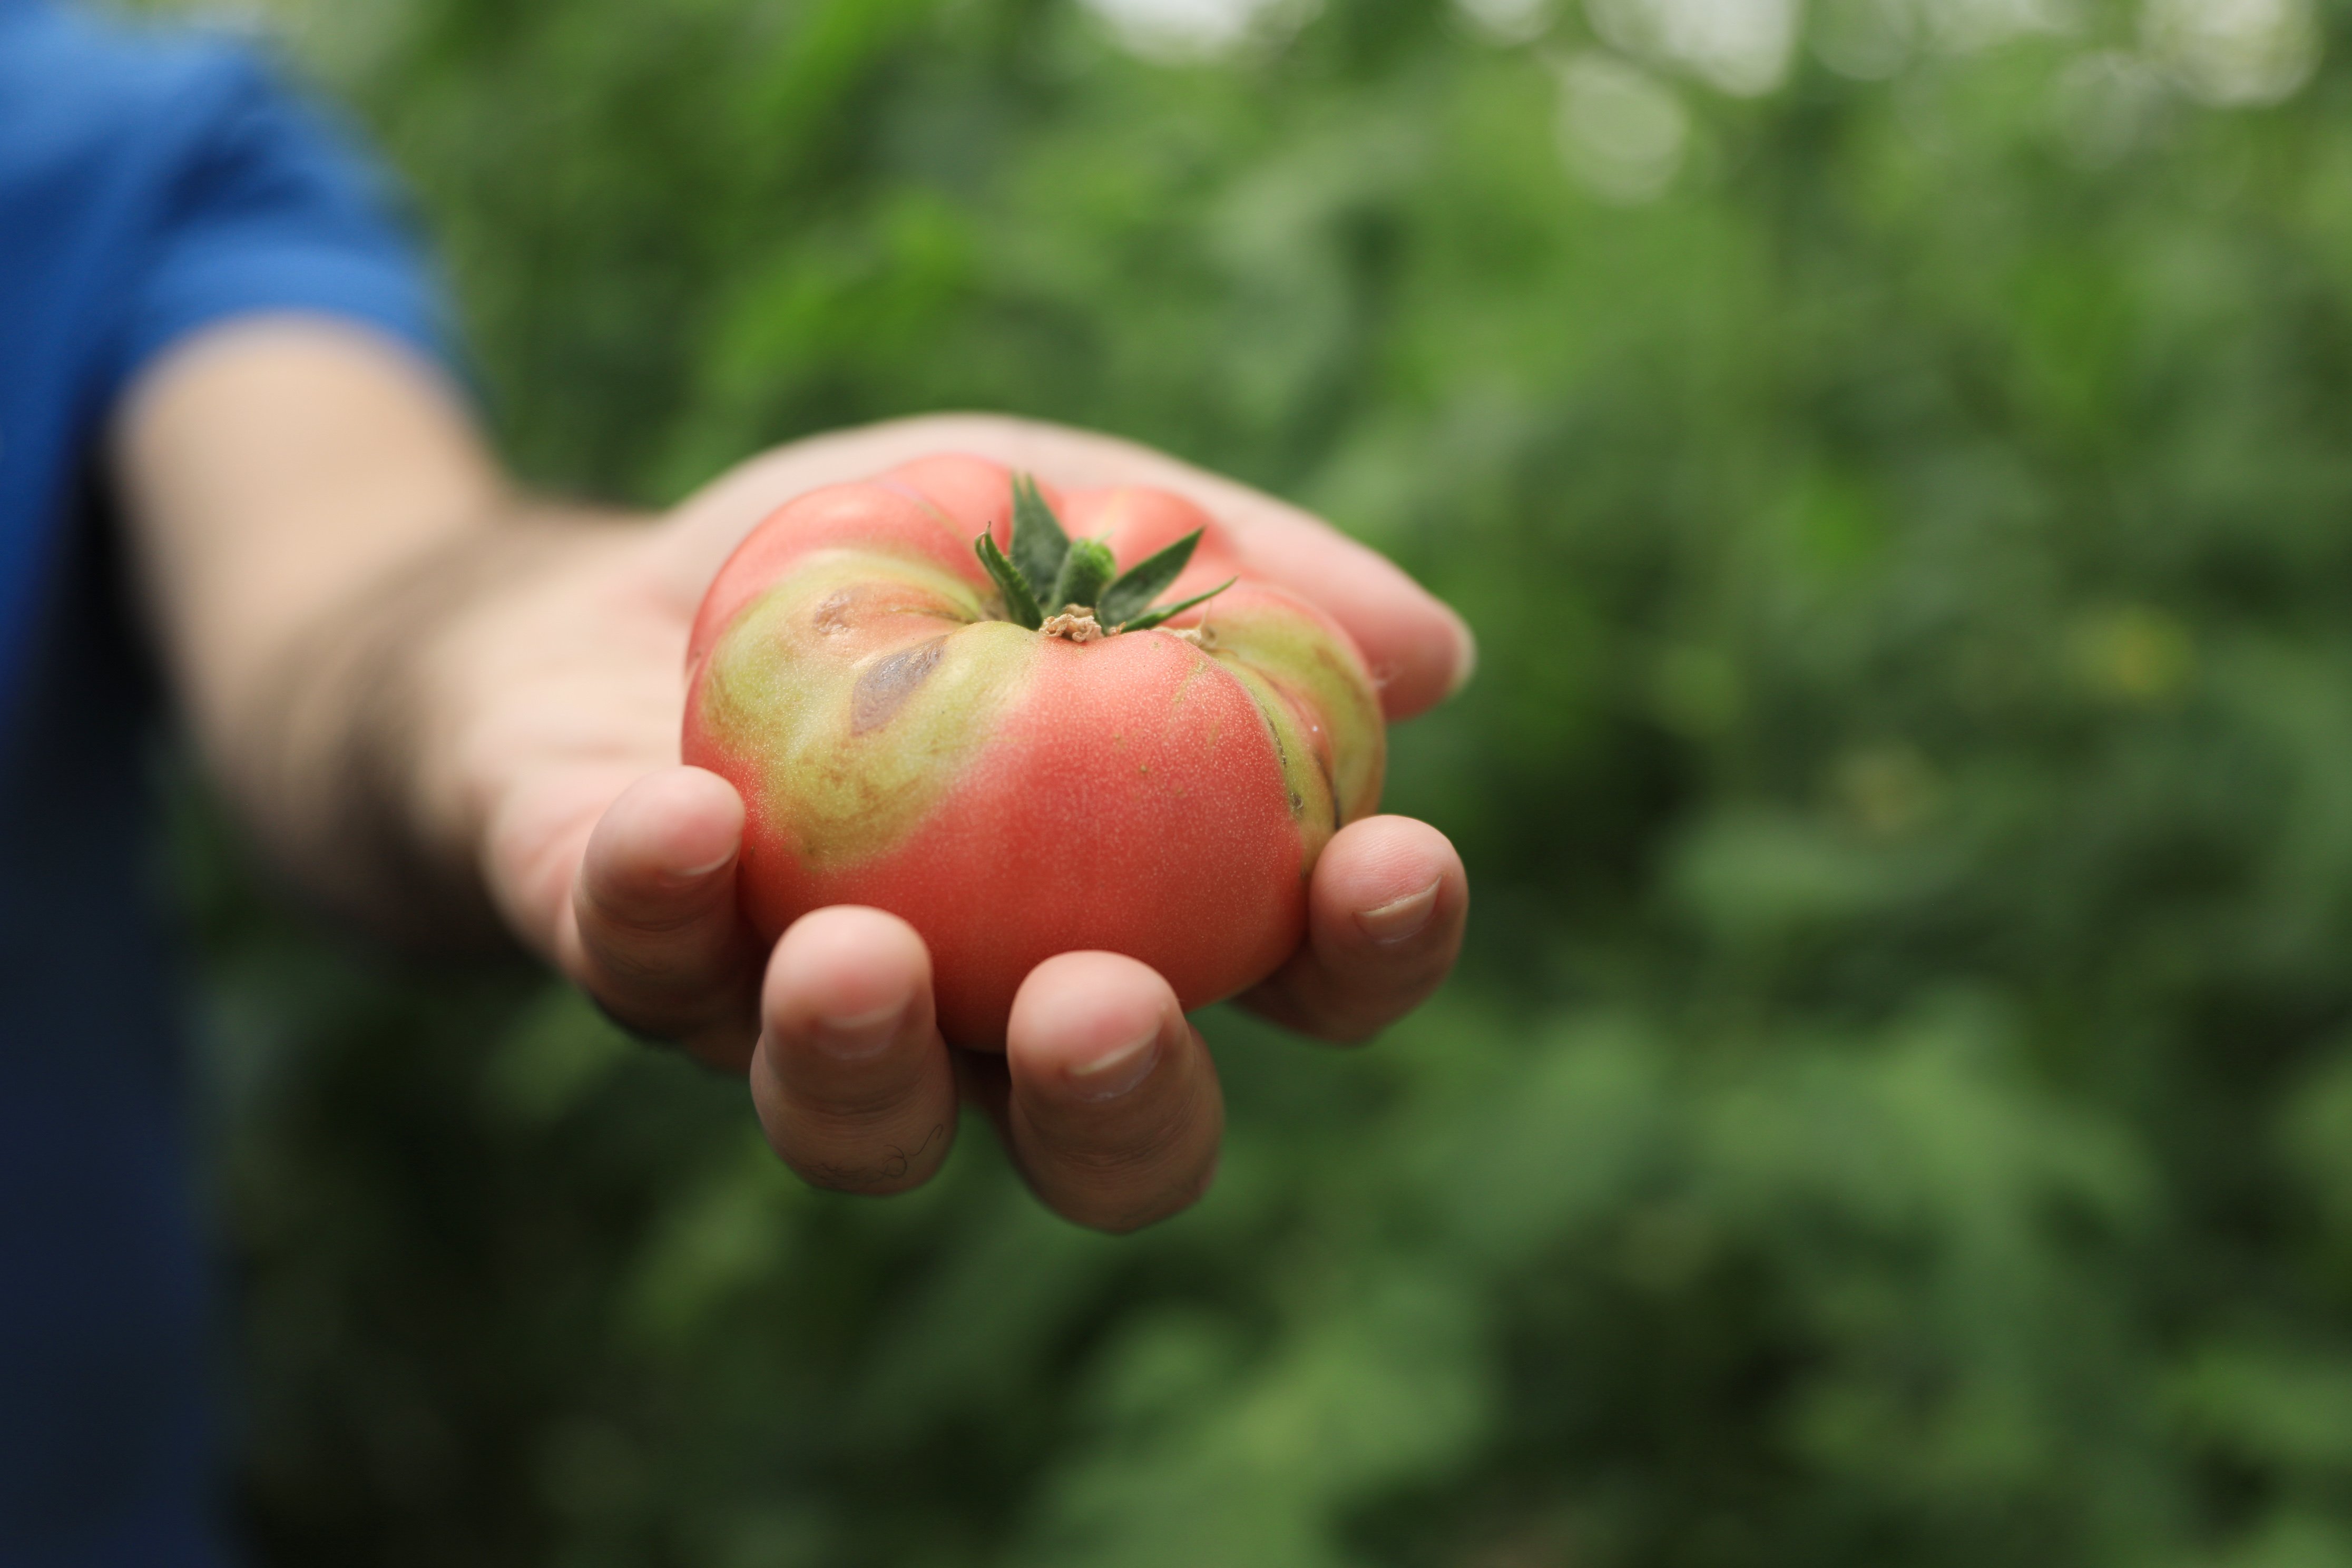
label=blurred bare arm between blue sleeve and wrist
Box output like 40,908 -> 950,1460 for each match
113,317 -> 644,938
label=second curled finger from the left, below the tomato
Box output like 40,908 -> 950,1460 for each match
750,905 -> 955,1192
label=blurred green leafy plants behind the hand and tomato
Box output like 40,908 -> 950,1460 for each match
138,0 -> 2352,1568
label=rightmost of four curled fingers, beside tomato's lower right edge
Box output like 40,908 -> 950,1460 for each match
1242,816 -> 1470,1042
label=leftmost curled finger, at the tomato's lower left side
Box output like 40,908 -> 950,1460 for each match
560,769 -> 760,1072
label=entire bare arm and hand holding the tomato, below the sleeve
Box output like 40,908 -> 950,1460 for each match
111,317 -> 1472,1230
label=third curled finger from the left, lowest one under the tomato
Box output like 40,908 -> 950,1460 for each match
1004,952 -> 1226,1232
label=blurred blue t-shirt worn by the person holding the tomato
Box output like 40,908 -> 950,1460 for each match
0,0 -> 440,1568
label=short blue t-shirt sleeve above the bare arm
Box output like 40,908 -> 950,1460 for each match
113,54 -> 458,386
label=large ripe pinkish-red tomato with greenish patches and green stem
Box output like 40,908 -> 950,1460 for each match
684,456 -> 1388,1048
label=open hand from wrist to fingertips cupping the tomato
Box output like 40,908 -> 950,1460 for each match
426,416 -> 1472,1230
